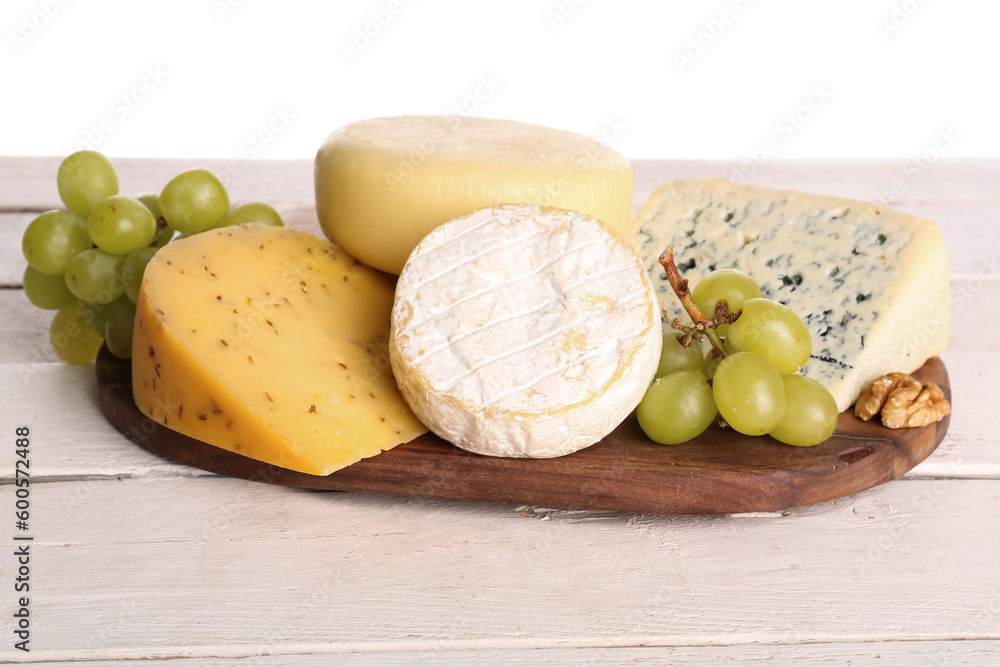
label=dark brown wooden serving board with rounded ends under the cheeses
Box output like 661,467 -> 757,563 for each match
97,348 -> 951,514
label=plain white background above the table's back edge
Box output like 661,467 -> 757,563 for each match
0,0 -> 1000,159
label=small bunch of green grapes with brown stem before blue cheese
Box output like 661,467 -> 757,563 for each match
637,269 -> 837,447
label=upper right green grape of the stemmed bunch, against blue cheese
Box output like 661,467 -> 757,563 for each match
728,299 -> 812,375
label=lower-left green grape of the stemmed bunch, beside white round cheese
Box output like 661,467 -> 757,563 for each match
636,370 -> 717,445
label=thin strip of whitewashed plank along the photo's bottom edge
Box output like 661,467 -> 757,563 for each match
23,641 -> 1000,667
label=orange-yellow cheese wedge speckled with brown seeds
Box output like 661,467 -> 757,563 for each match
132,225 -> 427,475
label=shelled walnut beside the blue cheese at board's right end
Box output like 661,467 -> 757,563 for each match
854,373 -> 951,428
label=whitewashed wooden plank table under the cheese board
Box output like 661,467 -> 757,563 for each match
0,158 -> 1000,667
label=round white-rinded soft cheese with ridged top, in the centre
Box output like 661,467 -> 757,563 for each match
390,204 -> 662,458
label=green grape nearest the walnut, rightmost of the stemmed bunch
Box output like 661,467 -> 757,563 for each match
769,375 -> 837,447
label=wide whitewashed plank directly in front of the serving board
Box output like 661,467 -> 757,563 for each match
0,474 -> 1000,661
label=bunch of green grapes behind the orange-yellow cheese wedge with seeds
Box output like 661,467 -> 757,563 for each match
21,151 -> 282,364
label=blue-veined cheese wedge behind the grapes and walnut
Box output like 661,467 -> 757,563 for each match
633,179 -> 951,411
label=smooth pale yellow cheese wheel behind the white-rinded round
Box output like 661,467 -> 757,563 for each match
316,116 -> 633,275
